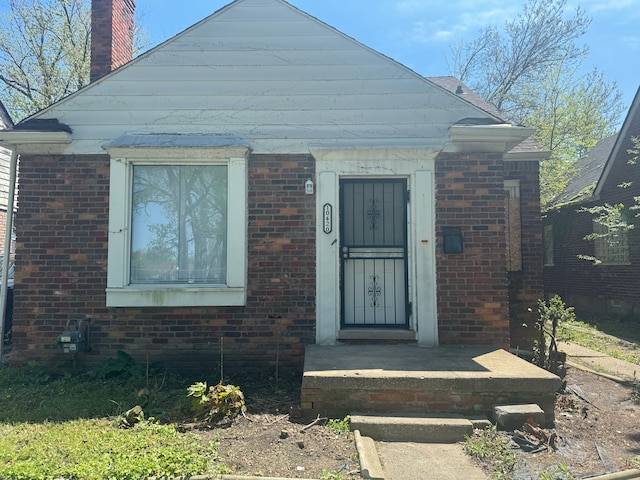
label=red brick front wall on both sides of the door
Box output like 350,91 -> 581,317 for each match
13,154 -> 542,370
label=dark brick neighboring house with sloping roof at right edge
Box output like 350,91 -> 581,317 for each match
544,86 -> 640,317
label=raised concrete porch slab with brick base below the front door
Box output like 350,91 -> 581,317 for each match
301,345 -> 561,423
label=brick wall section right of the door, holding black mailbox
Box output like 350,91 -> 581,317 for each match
436,154 -> 543,349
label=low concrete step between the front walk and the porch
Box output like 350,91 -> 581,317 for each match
351,414 -> 473,443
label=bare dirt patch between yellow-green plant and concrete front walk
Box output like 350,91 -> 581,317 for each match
188,376 -> 360,480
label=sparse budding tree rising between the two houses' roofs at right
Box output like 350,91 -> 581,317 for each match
452,0 -> 624,206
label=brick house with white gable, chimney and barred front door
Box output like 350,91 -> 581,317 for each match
0,0 -> 544,368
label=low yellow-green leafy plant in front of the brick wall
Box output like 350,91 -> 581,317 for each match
187,382 -> 247,423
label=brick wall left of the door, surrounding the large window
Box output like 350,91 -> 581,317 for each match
13,156 -> 315,371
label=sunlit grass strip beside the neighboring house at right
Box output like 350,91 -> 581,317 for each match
558,320 -> 640,365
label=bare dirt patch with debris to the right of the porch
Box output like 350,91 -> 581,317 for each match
514,368 -> 640,479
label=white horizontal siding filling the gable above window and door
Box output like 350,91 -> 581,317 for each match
30,0 -> 496,153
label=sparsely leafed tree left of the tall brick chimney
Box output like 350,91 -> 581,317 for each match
0,0 -> 91,119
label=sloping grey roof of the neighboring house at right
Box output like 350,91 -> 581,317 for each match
549,88 -> 640,207
